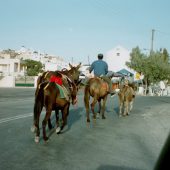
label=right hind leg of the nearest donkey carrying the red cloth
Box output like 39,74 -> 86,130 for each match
42,107 -> 52,141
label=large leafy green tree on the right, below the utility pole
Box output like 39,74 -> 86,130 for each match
126,47 -> 170,84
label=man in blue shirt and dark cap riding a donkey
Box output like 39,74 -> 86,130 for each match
85,54 -> 116,97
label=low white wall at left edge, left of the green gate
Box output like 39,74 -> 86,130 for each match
0,76 -> 15,87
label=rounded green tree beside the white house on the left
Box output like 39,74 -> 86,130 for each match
23,59 -> 43,76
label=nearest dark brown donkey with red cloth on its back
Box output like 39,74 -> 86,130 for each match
34,78 -> 77,142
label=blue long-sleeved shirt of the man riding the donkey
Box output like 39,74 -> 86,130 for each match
89,60 -> 108,76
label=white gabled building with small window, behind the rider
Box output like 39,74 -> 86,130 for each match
104,46 -> 133,73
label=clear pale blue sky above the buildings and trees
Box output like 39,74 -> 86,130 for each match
0,0 -> 170,63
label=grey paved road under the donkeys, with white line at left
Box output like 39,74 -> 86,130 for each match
0,88 -> 170,170
